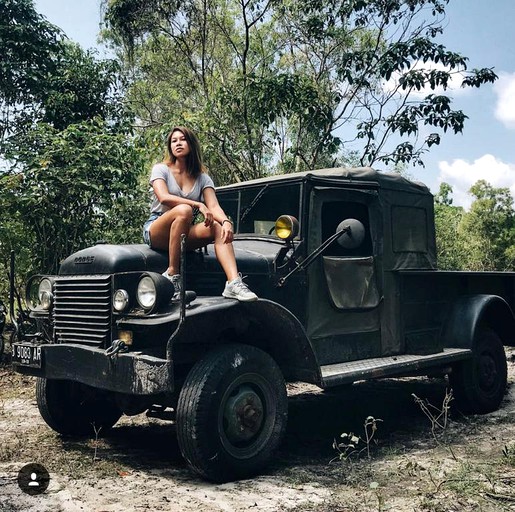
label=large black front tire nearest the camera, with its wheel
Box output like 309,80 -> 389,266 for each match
176,344 -> 288,482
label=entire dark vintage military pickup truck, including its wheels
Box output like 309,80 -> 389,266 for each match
12,168 -> 515,481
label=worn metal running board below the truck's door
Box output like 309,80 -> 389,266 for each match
321,348 -> 472,388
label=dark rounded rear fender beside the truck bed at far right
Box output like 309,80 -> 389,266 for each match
442,294 -> 515,349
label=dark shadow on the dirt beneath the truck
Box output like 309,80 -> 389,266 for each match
58,379 -> 456,477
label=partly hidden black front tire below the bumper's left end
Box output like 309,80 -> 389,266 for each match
36,377 -> 122,436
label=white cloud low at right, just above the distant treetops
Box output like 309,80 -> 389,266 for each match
438,154 -> 515,208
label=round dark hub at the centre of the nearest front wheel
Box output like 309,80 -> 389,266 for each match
224,385 -> 264,444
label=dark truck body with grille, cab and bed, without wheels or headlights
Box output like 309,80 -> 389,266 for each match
13,168 -> 515,479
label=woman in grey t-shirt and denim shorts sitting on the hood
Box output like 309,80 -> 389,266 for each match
143,126 -> 257,302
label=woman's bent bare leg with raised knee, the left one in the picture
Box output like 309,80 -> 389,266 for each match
150,204 -> 193,275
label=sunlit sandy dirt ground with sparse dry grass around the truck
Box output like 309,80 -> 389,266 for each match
0,338 -> 515,512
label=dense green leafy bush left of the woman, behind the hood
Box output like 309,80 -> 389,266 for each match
0,119 -> 146,272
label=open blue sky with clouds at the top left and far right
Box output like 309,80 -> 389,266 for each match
35,0 -> 515,207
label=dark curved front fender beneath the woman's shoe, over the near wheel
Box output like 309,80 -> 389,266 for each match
172,298 -> 321,384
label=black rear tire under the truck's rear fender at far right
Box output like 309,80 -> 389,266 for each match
449,328 -> 508,414
